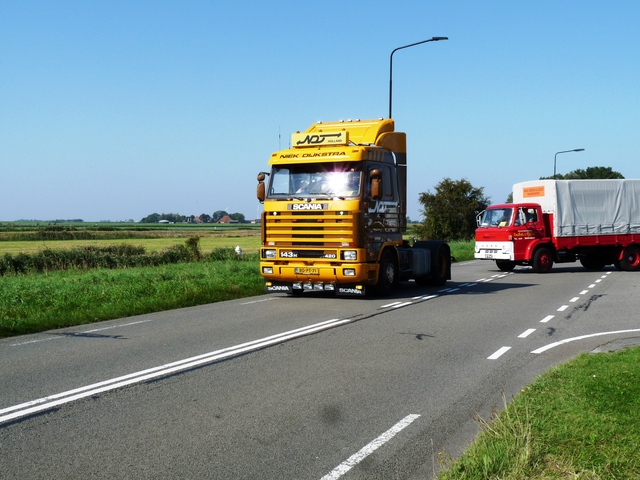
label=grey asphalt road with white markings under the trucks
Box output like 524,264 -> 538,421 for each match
0,261 -> 640,479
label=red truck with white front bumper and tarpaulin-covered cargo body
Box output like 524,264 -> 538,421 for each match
474,180 -> 640,273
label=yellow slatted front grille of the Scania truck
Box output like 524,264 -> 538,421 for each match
265,210 -> 357,247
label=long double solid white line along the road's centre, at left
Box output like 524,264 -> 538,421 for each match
0,319 -> 354,423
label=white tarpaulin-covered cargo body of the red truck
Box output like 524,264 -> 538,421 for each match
513,179 -> 640,237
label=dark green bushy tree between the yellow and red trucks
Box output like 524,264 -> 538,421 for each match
415,178 -> 490,241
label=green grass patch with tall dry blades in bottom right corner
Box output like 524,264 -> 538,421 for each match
438,348 -> 640,480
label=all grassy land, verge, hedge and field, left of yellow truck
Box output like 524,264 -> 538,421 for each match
0,225 -> 263,337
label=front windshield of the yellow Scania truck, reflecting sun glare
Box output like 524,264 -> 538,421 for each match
267,163 -> 361,198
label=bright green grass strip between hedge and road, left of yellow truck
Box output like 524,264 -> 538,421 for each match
0,257 -> 264,337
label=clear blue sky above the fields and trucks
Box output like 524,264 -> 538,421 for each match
0,0 -> 640,221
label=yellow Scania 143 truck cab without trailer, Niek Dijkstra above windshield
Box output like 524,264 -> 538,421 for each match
257,119 -> 451,296
